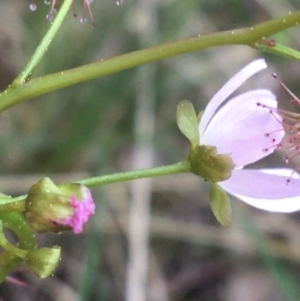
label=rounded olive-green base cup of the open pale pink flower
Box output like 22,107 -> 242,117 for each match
188,145 -> 234,183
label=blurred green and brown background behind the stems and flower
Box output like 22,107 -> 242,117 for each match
0,0 -> 300,301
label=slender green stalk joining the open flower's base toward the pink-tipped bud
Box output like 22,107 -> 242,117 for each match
75,161 -> 190,187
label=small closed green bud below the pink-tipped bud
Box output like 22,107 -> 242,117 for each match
26,246 -> 61,278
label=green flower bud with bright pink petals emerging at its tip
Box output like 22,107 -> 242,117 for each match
25,178 -> 96,234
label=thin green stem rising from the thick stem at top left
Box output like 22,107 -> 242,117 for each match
12,0 -> 73,85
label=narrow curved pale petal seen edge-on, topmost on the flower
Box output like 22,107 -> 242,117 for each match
199,59 -> 267,137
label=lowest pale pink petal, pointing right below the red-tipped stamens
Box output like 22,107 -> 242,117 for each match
219,169 -> 300,212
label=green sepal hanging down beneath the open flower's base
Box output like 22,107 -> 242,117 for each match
209,184 -> 231,227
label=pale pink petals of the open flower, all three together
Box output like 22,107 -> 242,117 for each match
199,59 -> 300,212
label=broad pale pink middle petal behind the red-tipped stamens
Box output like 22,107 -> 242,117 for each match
201,90 -> 284,167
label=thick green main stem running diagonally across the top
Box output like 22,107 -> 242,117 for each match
0,10 -> 300,112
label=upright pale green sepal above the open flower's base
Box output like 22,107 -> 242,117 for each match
176,100 -> 200,147
